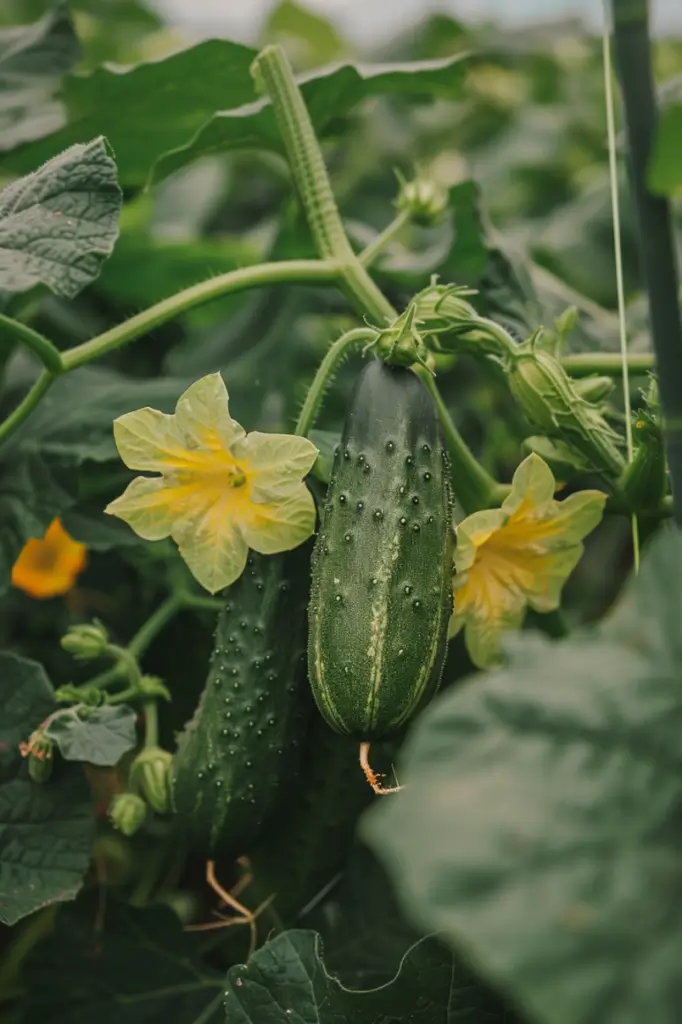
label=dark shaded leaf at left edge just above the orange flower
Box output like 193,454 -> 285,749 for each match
0,451 -> 74,594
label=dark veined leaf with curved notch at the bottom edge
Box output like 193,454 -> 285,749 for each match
225,931 -> 505,1024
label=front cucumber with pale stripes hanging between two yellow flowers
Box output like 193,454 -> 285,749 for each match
308,360 -> 454,741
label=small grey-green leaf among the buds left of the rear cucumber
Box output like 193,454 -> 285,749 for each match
45,705 -> 137,768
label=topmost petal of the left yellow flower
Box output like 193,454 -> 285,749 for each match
175,373 -> 244,451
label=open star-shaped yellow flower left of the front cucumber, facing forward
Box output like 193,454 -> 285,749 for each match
104,373 -> 317,594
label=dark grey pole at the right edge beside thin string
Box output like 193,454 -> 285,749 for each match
610,0 -> 682,526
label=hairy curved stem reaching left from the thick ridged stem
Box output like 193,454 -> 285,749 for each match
61,259 -> 341,370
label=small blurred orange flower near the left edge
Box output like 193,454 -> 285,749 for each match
12,519 -> 87,598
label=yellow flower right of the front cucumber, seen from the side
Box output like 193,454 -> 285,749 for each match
450,455 -> 606,668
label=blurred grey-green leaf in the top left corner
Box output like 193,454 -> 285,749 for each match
0,4 -> 81,153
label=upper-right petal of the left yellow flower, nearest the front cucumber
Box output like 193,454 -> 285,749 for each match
232,430 -> 318,502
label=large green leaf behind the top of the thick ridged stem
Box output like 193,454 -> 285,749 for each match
5,39 -> 465,185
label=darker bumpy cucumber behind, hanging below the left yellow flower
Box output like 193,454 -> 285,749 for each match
172,542 -> 314,857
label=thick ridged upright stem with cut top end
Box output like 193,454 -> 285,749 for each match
252,46 -> 397,326
